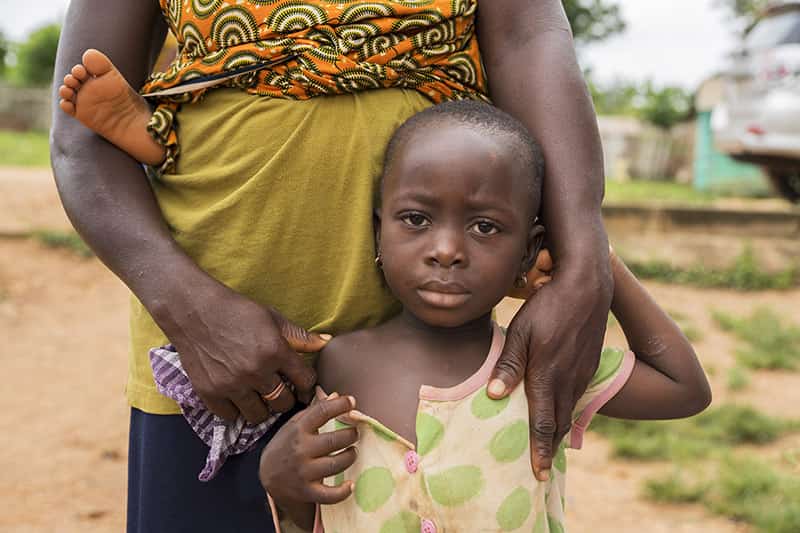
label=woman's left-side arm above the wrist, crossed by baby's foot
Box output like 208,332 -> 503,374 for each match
50,0 -> 208,313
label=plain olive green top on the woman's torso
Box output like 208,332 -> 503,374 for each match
127,89 -> 430,414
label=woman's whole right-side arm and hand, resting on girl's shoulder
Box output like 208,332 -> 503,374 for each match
478,0 -> 612,478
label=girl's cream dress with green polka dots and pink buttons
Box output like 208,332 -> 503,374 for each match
274,327 -> 634,533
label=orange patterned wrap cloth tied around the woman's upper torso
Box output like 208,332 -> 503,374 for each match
142,0 -> 488,172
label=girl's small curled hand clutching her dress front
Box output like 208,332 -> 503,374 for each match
258,393 -> 358,508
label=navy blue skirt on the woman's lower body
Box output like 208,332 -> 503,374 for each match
128,409 -> 296,533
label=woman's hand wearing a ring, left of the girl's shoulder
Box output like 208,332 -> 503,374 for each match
159,277 -> 330,424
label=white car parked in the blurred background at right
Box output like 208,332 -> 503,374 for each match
711,1 -> 800,202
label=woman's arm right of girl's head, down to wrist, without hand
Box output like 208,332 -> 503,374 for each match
478,0 -> 611,270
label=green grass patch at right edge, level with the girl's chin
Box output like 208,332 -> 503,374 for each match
712,307 -> 800,370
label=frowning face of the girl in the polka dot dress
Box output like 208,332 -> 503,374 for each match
378,124 -> 542,327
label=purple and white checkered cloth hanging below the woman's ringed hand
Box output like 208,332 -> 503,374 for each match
150,345 -> 279,481
